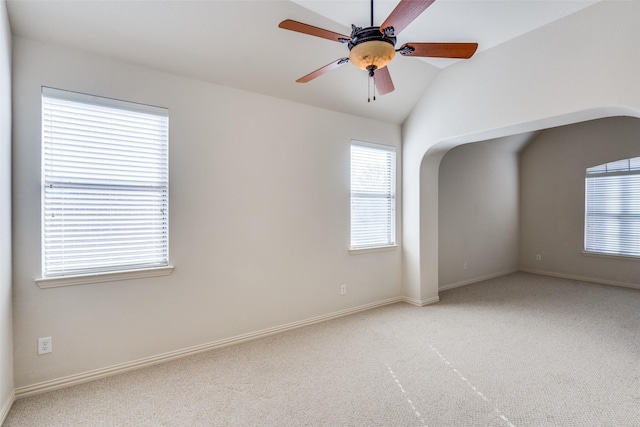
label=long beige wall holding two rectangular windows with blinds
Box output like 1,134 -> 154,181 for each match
13,37 -> 401,391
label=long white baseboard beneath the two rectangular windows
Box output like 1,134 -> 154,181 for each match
13,297 -> 404,400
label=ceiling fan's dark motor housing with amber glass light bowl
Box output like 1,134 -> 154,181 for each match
348,25 -> 396,72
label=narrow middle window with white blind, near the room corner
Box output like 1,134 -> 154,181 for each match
351,142 -> 396,249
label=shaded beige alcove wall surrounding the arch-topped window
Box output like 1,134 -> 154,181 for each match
520,117 -> 640,287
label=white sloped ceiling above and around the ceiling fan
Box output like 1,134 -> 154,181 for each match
7,0 -> 597,124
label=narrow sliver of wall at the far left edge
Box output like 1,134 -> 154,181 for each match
0,0 -> 13,418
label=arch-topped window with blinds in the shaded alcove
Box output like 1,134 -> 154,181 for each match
584,157 -> 640,257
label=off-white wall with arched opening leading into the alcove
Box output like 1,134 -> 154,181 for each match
403,1 -> 640,300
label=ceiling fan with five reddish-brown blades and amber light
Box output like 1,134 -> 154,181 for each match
278,0 -> 478,100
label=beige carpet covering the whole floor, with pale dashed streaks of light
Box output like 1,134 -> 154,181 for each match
4,273 -> 640,427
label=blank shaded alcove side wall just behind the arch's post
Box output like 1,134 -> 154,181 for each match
438,135 -> 528,290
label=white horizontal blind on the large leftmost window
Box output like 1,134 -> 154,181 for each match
42,88 -> 169,278
